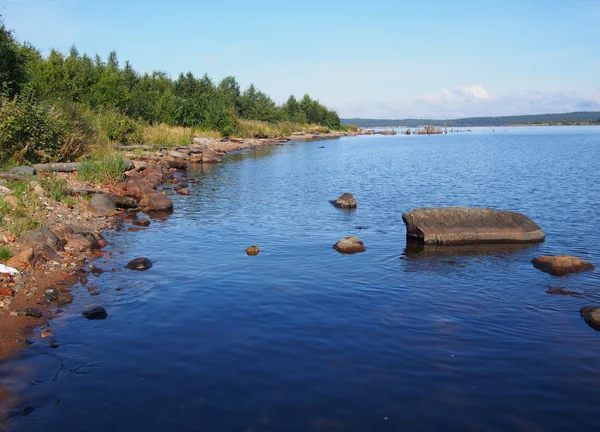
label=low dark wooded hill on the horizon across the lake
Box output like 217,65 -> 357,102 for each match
342,111 -> 600,128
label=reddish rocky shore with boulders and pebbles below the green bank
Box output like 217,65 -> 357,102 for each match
0,132 -> 361,361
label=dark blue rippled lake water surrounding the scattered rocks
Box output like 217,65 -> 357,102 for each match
0,127 -> 600,431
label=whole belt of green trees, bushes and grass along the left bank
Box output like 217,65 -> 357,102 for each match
0,16 -> 344,162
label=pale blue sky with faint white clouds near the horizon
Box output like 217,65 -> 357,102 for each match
0,0 -> 600,119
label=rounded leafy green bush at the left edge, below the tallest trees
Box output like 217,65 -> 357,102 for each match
0,93 -> 62,164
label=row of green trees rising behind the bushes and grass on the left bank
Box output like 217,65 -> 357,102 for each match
0,16 -> 344,163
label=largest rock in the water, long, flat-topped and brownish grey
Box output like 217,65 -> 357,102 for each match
402,207 -> 546,244
